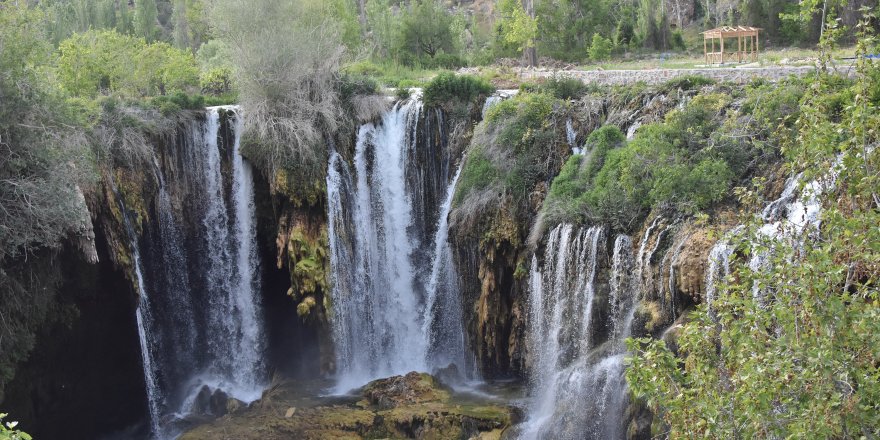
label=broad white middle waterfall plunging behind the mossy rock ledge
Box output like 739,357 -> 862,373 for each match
327,99 -> 466,392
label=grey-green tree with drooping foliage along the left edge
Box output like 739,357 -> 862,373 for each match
0,2 -> 95,398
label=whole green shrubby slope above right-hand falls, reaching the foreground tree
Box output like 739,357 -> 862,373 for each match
542,77 -> 804,230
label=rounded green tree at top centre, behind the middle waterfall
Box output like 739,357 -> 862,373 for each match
400,0 -> 455,58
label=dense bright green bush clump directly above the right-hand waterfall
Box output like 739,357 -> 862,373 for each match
540,94 -> 755,230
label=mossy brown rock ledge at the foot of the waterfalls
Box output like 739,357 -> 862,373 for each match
181,372 -> 515,440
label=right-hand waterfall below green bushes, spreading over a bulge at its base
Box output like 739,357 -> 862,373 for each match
519,225 -> 635,439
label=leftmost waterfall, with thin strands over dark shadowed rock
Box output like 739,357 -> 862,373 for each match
123,107 -> 265,439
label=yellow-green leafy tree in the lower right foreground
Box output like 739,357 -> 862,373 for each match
627,19 -> 880,438
